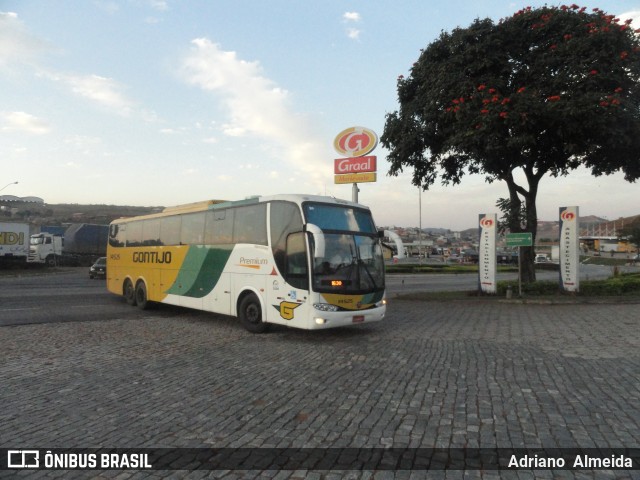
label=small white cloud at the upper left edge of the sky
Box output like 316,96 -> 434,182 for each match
0,12 -> 47,67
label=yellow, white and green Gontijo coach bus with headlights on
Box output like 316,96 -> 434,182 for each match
107,195 -> 386,333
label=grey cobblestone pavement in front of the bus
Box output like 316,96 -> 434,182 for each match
0,299 -> 640,479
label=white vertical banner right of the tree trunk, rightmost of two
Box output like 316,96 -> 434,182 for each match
560,207 -> 580,292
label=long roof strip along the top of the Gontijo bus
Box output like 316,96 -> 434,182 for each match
111,194 -> 369,223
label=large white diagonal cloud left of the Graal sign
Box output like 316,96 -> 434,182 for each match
181,38 -> 327,180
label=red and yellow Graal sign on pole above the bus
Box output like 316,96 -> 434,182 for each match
333,127 -> 378,203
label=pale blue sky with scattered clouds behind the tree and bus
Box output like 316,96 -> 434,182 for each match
0,0 -> 640,230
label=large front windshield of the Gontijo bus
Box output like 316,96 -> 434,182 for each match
304,204 -> 384,294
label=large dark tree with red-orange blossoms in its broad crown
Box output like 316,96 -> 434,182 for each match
381,4 -> 640,279
